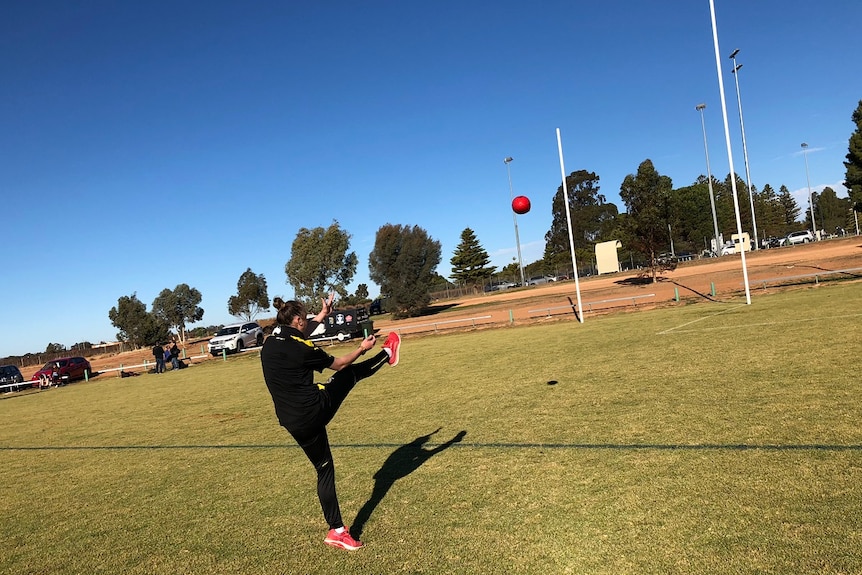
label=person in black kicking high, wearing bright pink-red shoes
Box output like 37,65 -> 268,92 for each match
260,295 -> 401,551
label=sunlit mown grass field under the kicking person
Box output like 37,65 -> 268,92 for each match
0,282 -> 862,575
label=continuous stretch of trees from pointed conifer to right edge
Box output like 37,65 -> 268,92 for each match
451,100 -> 862,289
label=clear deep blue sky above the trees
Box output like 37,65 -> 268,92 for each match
0,0 -> 862,357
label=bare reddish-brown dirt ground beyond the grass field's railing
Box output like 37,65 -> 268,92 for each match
22,236 -> 862,378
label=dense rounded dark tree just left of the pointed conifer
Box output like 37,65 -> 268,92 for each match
368,224 -> 440,317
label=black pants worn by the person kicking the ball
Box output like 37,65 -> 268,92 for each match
288,351 -> 389,529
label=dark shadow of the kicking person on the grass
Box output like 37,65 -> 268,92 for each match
350,428 -> 467,539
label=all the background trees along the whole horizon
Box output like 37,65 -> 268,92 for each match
49,100 -> 862,354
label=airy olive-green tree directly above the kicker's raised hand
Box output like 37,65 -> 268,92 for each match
284,220 -> 359,307
